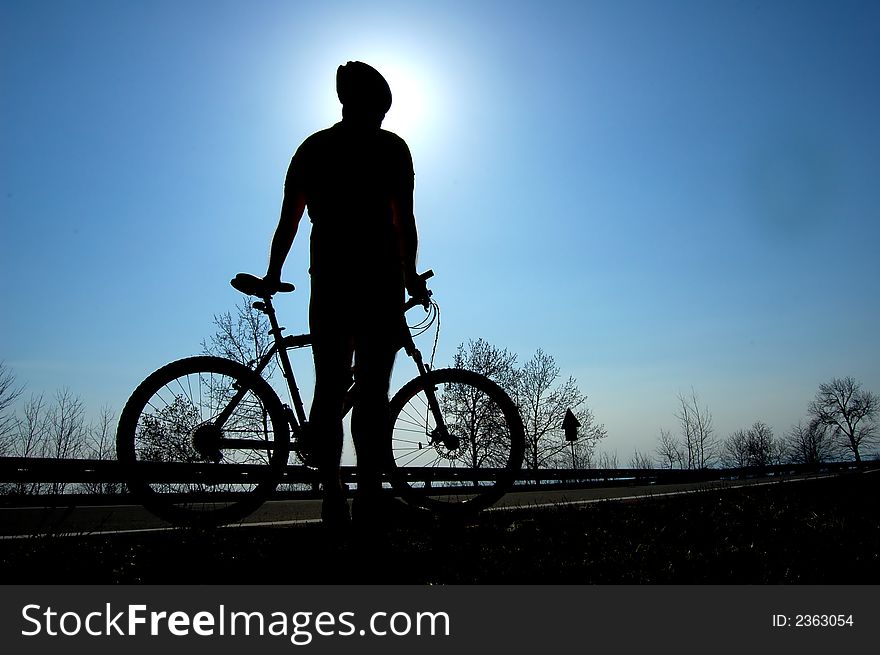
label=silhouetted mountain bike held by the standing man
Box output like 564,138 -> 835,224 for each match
116,271 -> 524,526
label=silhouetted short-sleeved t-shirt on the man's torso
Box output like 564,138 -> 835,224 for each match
285,123 -> 414,286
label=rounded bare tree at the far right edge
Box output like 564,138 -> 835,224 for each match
808,377 -> 880,464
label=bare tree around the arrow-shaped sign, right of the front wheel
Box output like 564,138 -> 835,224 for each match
512,349 -> 607,470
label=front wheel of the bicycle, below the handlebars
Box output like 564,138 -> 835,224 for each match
391,369 -> 525,514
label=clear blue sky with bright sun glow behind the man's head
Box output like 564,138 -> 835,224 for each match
0,0 -> 880,462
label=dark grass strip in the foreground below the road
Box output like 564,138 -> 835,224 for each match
0,474 -> 880,585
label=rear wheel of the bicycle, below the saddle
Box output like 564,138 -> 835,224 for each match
116,357 -> 290,527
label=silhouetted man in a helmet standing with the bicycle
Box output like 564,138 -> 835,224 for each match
266,62 -> 426,524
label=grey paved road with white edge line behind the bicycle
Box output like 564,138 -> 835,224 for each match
0,475 -> 832,539
